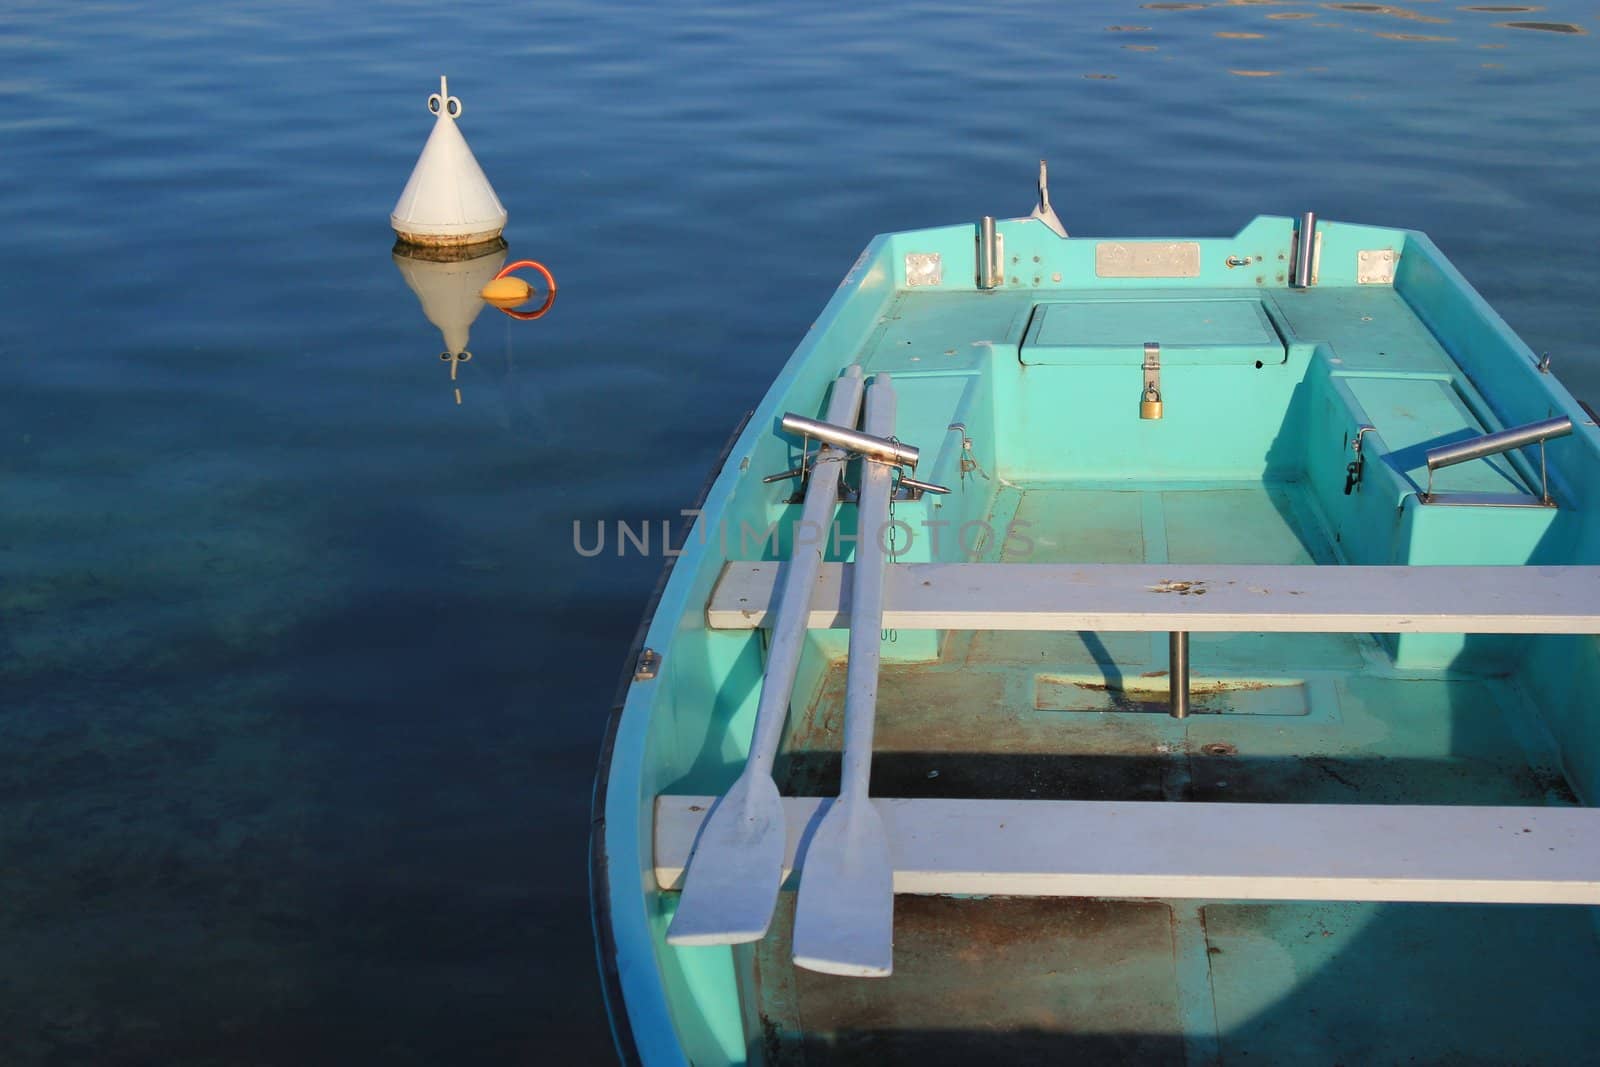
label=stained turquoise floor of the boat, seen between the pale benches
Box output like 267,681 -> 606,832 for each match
754,483 -> 1600,1064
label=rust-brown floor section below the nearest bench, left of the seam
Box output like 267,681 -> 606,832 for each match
757,894 -> 1184,1065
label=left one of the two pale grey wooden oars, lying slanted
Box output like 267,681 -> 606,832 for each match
667,365 -> 862,945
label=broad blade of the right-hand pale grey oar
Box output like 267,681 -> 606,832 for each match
794,797 -> 894,977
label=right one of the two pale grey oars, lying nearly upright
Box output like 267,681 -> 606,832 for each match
794,374 -> 894,977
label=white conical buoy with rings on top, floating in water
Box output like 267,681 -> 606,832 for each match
389,78 -> 506,246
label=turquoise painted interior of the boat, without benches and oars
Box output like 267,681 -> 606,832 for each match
614,212 -> 1600,1064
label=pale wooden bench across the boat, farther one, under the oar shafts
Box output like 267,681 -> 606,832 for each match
706,561 -> 1600,633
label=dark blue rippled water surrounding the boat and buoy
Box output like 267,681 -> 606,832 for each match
0,0 -> 1600,1065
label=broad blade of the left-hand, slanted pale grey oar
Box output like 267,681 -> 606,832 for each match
667,774 -> 787,945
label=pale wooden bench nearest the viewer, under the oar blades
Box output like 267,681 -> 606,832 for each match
654,797 -> 1600,904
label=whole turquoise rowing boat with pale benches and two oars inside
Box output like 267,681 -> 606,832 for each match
590,174 -> 1600,1065
